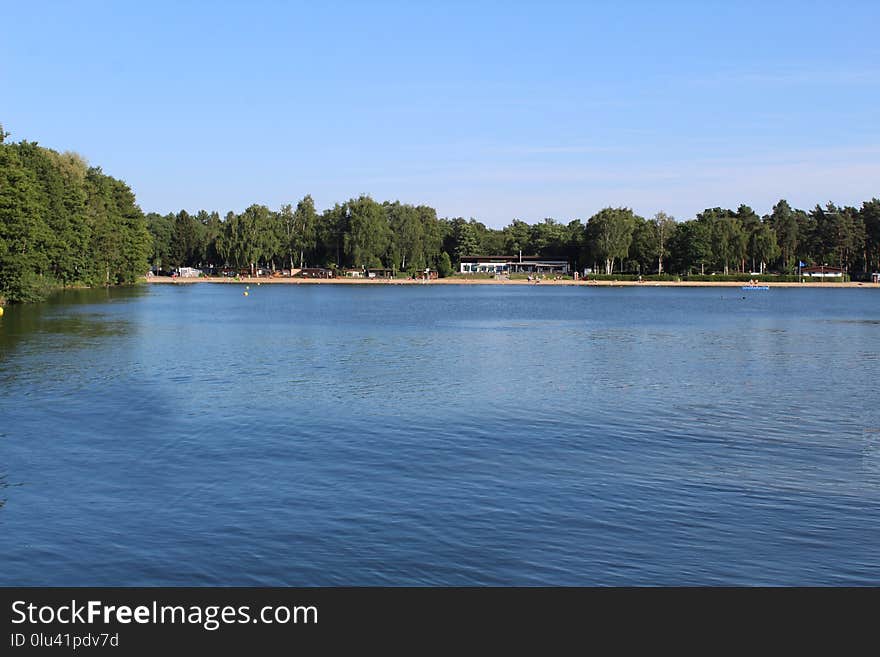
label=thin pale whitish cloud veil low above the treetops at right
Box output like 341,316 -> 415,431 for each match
334,147 -> 880,226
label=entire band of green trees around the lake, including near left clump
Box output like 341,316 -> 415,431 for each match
0,126 -> 880,301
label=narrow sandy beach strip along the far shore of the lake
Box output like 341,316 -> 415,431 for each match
142,276 -> 880,290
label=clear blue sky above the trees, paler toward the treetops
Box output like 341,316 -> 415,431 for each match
0,0 -> 880,227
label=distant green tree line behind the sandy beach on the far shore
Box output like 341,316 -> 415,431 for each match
147,196 -> 880,278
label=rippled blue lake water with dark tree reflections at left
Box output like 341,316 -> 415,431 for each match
0,285 -> 880,585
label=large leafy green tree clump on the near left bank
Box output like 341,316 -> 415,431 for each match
0,126 -> 152,301
